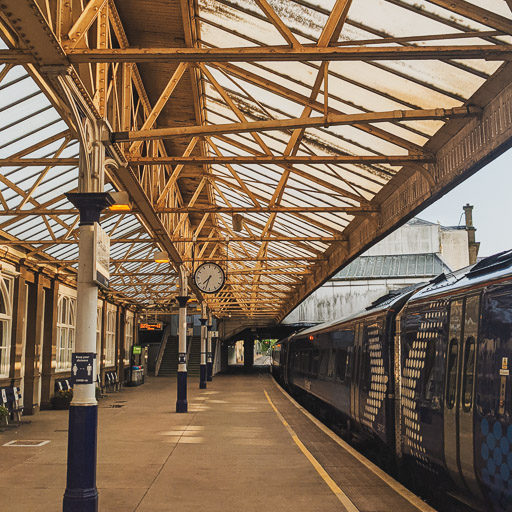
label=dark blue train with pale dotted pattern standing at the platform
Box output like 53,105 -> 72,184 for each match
272,251 -> 512,512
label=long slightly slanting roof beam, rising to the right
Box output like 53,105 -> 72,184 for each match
112,106 -> 481,142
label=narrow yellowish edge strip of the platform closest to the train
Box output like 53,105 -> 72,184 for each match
270,375 -> 437,512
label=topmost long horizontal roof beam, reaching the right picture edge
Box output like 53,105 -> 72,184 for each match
50,45 -> 512,64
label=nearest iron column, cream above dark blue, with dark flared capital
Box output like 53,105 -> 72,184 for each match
63,192 -> 113,512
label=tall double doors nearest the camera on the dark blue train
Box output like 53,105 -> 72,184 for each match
444,295 -> 480,496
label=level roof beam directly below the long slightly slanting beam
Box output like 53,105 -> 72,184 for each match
130,155 -> 434,166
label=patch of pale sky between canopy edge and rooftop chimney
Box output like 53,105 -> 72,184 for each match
417,149 -> 512,256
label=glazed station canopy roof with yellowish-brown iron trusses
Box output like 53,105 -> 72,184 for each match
0,0 -> 512,323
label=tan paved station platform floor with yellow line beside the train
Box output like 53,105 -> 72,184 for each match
0,373 -> 433,512
